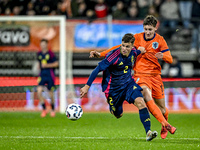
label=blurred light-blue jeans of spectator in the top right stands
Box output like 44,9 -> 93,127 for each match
179,0 -> 193,29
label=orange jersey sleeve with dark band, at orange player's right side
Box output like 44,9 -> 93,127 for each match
160,38 -> 173,64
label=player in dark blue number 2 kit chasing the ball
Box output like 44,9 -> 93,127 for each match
80,33 -> 157,141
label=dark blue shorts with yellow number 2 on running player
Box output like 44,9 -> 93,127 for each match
107,83 -> 143,116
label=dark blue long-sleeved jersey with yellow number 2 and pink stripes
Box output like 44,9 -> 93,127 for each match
87,47 -> 141,93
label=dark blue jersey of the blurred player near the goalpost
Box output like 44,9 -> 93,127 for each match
37,50 -> 56,78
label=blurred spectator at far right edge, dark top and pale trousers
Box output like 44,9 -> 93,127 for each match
190,0 -> 200,53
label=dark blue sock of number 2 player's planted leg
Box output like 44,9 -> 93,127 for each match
139,107 -> 151,133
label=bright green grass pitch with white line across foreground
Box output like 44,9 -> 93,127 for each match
0,112 -> 200,150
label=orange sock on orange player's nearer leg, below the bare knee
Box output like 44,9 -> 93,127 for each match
146,100 -> 169,126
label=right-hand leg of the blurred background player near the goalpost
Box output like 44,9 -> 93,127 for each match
47,78 -> 56,117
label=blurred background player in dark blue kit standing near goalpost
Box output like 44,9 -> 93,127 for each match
37,39 -> 58,117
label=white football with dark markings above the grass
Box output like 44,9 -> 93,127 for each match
66,103 -> 83,120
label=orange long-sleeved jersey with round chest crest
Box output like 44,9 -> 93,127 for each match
101,32 -> 172,75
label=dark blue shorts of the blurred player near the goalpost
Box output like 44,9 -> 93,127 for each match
38,76 -> 55,91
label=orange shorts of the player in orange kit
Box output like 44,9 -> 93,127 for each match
134,74 -> 165,99
